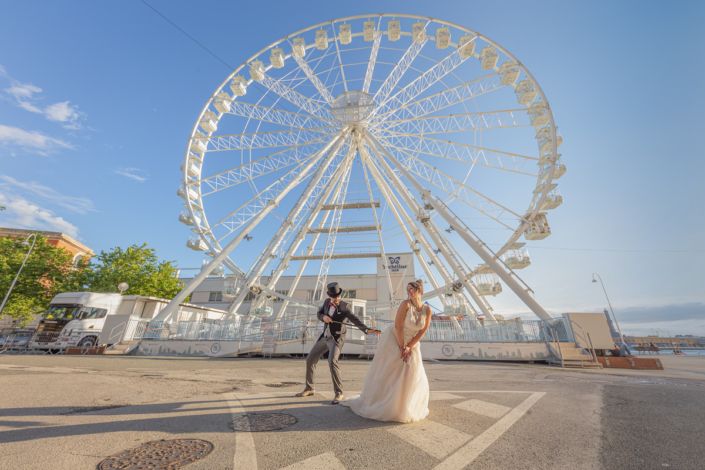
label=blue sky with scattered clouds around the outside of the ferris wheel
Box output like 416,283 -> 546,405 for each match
0,0 -> 705,334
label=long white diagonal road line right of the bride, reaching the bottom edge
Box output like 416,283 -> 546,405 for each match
434,392 -> 546,470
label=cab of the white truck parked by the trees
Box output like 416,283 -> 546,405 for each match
30,292 -> 121,351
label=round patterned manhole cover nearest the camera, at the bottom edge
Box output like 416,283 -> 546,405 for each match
98,439 -> 213,470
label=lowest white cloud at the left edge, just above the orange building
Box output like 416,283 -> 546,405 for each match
0,193 -> 78,238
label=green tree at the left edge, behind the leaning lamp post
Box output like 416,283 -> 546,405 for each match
0,236 -> 86,323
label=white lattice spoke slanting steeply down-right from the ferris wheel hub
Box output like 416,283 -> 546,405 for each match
376,138 -> 523,231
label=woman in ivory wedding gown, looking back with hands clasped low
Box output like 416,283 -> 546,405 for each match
341,280 -> 431,423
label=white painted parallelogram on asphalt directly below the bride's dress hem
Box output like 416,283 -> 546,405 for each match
387,419 -> 472,459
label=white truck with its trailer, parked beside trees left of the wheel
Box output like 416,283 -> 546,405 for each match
29,292 -> 227,352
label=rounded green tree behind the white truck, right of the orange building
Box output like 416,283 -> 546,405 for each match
88,243 -> 183,299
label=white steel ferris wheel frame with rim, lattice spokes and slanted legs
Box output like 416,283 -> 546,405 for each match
160,14 -> 564,320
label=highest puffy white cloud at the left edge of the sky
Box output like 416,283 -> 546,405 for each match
0,66 -> 84,130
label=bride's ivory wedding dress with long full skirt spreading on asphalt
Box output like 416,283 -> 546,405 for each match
341,304 -> 430,423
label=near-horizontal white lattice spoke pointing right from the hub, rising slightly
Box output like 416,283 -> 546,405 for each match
383,109 -> 531,136
